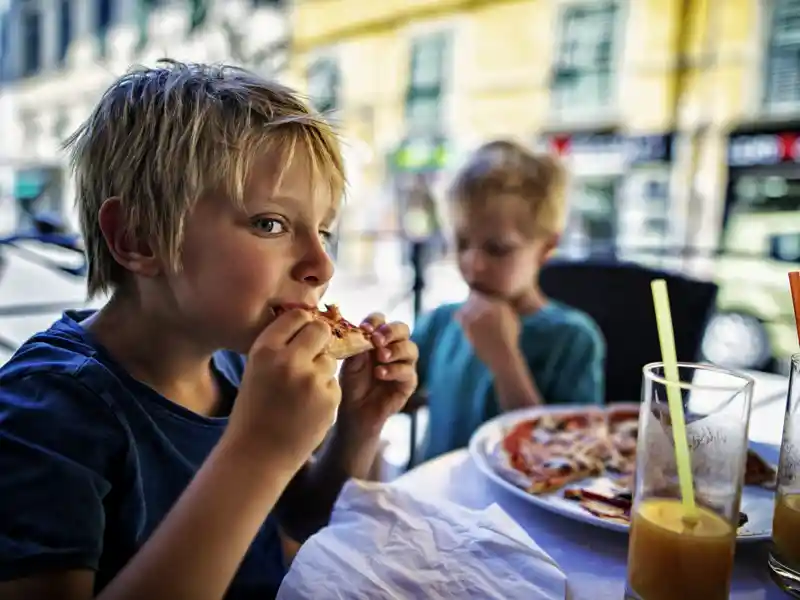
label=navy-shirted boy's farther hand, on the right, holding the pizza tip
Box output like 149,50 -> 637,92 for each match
337,314 -> 419,437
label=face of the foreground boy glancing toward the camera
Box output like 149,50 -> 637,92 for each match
162,152 -> 337,353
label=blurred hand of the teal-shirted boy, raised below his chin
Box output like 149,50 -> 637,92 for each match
456,292 -> 521,370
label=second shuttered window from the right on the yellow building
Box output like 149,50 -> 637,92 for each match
551,1 -> 619,111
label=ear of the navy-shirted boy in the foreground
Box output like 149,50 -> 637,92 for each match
98,197 -> 161,277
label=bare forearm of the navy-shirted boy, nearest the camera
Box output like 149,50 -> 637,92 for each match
98,438 -> 294,600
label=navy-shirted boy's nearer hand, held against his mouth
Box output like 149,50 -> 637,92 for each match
228,309 -> 342,470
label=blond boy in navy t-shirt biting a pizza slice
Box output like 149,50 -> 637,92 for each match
0,62 -> 417,600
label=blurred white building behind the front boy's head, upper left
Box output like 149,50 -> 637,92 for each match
0,0 -> 287,231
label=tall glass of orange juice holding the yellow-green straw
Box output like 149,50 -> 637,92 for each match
625,363 -> 753,600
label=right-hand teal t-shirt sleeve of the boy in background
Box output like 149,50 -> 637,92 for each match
548,322 -> 605,404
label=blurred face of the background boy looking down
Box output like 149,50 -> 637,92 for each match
453,198 -> 557,302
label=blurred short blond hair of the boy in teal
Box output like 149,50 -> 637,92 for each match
449,140 -> 567,235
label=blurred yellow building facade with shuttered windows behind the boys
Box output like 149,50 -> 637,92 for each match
291,0 -> 780,276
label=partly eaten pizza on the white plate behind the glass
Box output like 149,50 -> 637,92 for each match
499,405 -> 776,525
